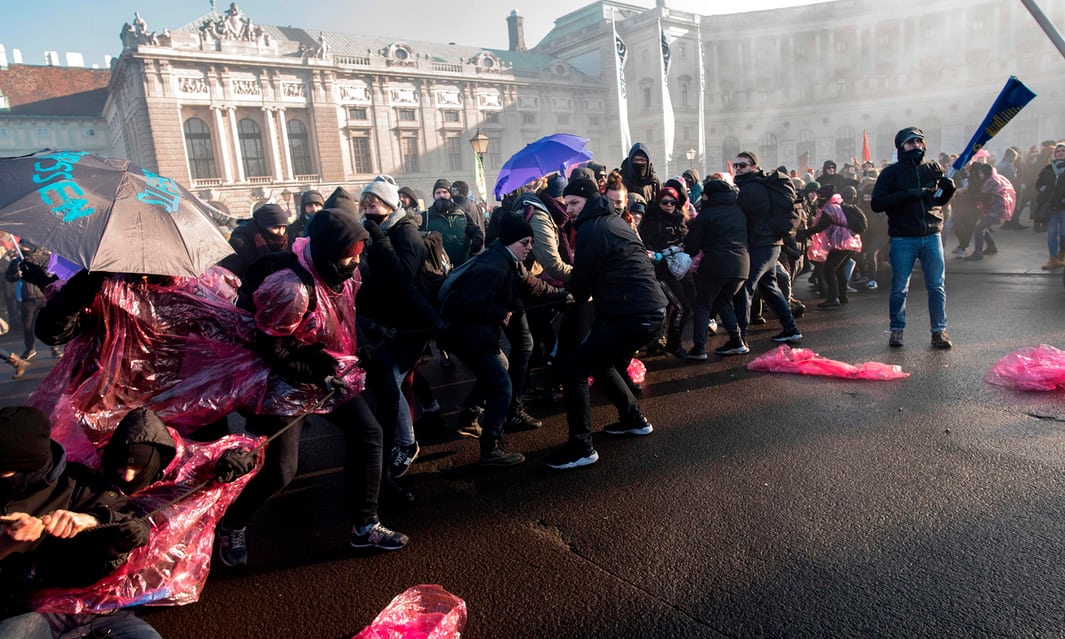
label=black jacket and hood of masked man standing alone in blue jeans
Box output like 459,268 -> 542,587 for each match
869,127 -> 954,237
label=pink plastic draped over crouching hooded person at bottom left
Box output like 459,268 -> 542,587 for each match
31,430 -> 263,615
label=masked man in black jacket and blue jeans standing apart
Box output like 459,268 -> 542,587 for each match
870,127 -> 954,348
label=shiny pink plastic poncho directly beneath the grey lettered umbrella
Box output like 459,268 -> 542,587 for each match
28,258 -> 365,468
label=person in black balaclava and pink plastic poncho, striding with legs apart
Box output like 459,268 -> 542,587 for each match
218,209 -> 408,567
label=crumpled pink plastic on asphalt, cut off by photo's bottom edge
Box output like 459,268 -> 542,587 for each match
353,584 -> 466,639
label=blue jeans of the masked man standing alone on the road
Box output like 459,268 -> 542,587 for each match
888,233 -> 947,332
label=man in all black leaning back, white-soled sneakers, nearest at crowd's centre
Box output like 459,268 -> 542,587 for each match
547,178 -> 666,470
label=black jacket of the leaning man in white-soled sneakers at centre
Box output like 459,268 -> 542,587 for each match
568,196 -> 666,320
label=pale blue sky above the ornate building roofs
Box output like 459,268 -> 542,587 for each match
0,0 -> 815,68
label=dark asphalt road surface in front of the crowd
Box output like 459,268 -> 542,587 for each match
0,225 -> 1065,639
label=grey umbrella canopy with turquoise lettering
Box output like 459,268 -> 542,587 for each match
0,150 -> 233,277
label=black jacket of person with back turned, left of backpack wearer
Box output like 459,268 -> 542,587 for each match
684,191 -> 751,279
